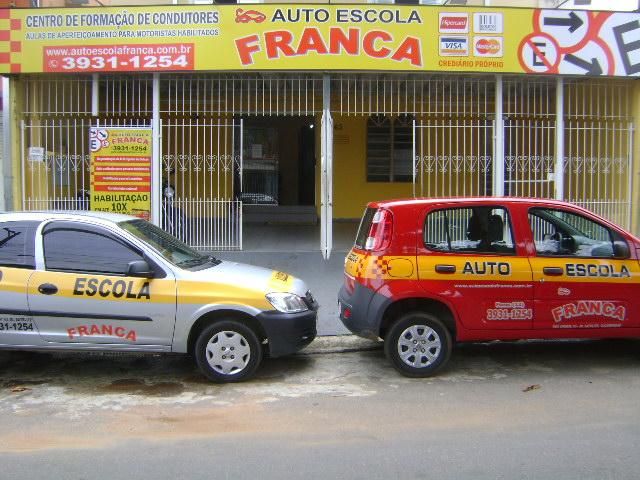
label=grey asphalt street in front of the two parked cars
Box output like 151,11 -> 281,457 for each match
0,339 -> 640,480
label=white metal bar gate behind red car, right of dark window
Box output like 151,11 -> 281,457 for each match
412,77 -> 634,228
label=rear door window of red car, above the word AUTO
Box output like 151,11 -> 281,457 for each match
424,206 -> 515,254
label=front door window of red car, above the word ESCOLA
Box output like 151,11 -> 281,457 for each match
529,208 -> 628,258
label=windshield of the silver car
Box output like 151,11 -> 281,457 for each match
118,220 -> 220,268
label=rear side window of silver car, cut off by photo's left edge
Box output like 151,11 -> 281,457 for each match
0,221 -> 40,269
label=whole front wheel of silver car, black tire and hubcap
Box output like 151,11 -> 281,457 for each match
194,320 -> 262,383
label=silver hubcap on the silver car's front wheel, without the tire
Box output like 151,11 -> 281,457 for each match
206,330 -> 251,375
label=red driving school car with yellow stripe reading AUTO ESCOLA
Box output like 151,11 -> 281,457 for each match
339,197 -> 640,377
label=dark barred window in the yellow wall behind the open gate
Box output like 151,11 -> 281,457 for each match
367,115 -> 413,182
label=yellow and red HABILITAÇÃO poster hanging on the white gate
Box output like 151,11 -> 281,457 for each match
89,127 -> 152,220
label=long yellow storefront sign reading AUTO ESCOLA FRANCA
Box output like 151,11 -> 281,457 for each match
0,4 -> 640,76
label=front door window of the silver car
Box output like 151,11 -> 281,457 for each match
43,222 -> 143,275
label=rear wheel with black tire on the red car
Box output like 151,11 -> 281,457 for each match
384,312 -> 452,378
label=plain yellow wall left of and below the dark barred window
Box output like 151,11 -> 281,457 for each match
333,115 -> 413,219
